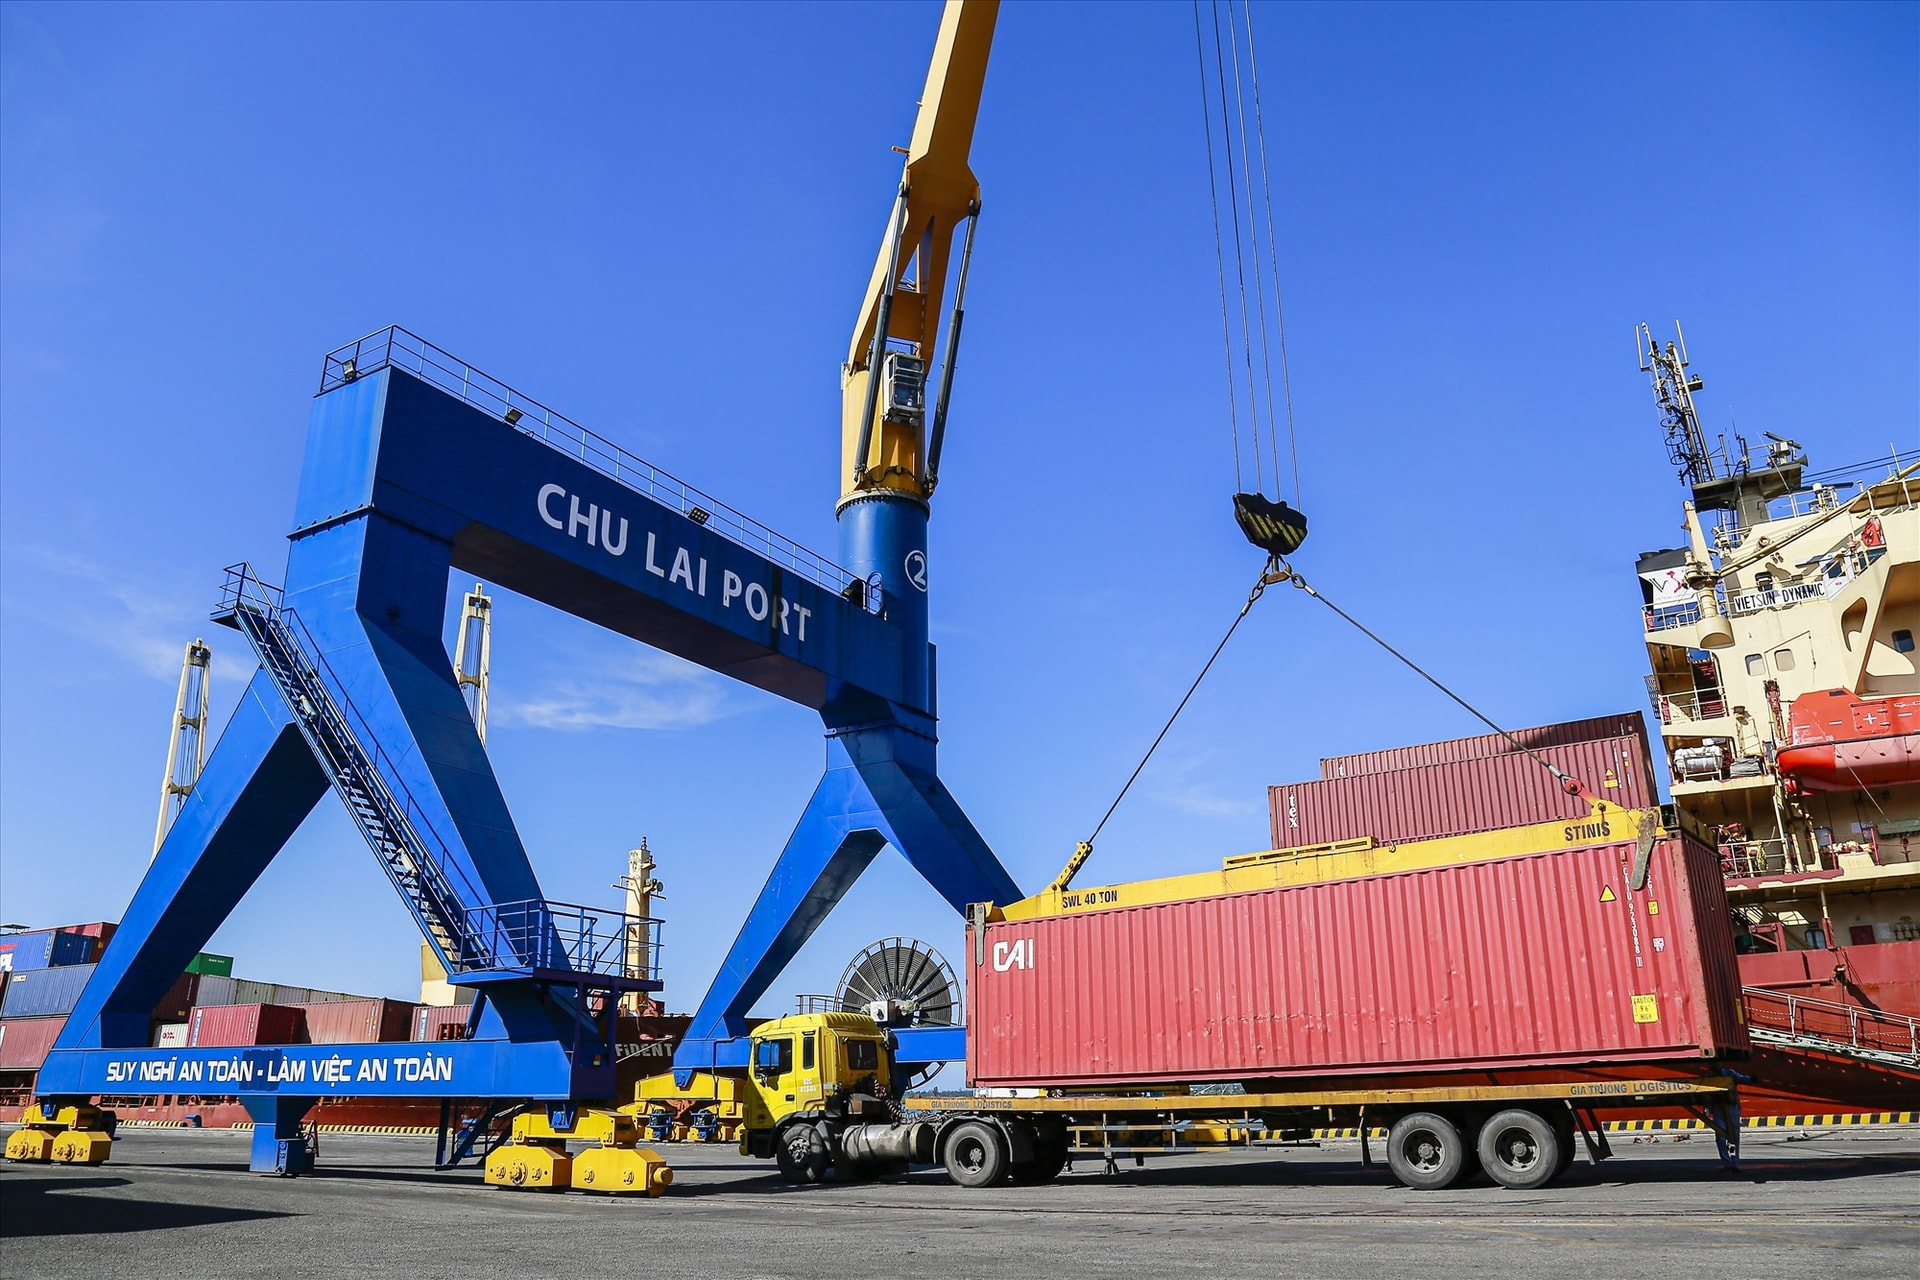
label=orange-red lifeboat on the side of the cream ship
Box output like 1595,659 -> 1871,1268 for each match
1778,689 -> 1920,791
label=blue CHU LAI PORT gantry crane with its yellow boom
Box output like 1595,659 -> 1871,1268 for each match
23,0 -> 1020,1190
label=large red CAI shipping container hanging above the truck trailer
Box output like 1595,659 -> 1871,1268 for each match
968,837 -> 1747,1088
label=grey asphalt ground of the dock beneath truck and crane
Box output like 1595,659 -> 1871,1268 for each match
0,1126 -> 1920,1280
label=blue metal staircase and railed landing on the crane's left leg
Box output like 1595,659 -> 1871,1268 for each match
213,564 -> 659,983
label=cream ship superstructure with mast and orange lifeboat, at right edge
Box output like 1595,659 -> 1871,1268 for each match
1638,326 -> 1920,1004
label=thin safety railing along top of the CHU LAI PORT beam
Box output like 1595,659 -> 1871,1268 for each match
321,324 -> 864,595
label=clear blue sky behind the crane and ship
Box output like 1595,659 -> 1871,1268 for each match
0,0 -> 1920,1011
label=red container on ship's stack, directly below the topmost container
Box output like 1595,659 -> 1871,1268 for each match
1267,737 -> 1659,848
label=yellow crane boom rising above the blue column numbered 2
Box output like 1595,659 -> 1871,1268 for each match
841,0 -> 1000,499
